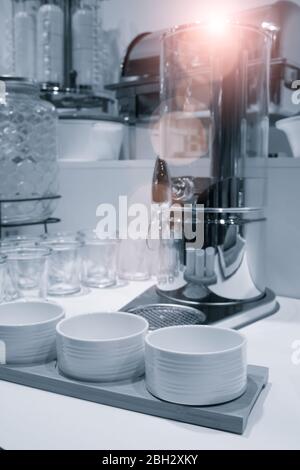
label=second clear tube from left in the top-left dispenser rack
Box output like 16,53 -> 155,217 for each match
37,0 -> 64,86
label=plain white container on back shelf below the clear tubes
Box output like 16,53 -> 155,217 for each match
58,118 -> 124,161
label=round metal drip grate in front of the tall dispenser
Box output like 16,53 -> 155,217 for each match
128,304 -> 206,330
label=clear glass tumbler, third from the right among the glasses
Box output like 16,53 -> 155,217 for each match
42,238 -> 81,296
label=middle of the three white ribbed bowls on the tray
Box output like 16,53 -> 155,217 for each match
56,312 -> 149,382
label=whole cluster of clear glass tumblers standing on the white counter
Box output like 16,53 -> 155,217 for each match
0,231 -> 124,302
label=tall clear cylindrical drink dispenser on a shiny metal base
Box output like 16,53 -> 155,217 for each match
157,21 -> 271,317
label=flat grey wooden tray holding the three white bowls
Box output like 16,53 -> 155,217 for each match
0,362 -> 269,434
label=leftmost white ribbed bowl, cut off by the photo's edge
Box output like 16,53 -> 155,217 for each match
0,301 -> 64,364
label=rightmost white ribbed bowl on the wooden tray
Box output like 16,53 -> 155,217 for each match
145,325 -> 247,406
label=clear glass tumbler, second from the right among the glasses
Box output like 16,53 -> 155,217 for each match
81,235 -> 118,289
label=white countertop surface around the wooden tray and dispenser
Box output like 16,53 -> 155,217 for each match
0,283 -> 300,450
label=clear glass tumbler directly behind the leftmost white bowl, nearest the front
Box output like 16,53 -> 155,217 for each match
2,247 -> 51,300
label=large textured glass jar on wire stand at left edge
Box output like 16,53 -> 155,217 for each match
0,77 -> 58,224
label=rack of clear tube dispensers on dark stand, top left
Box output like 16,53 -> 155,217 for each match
0,0 -> 115,112
